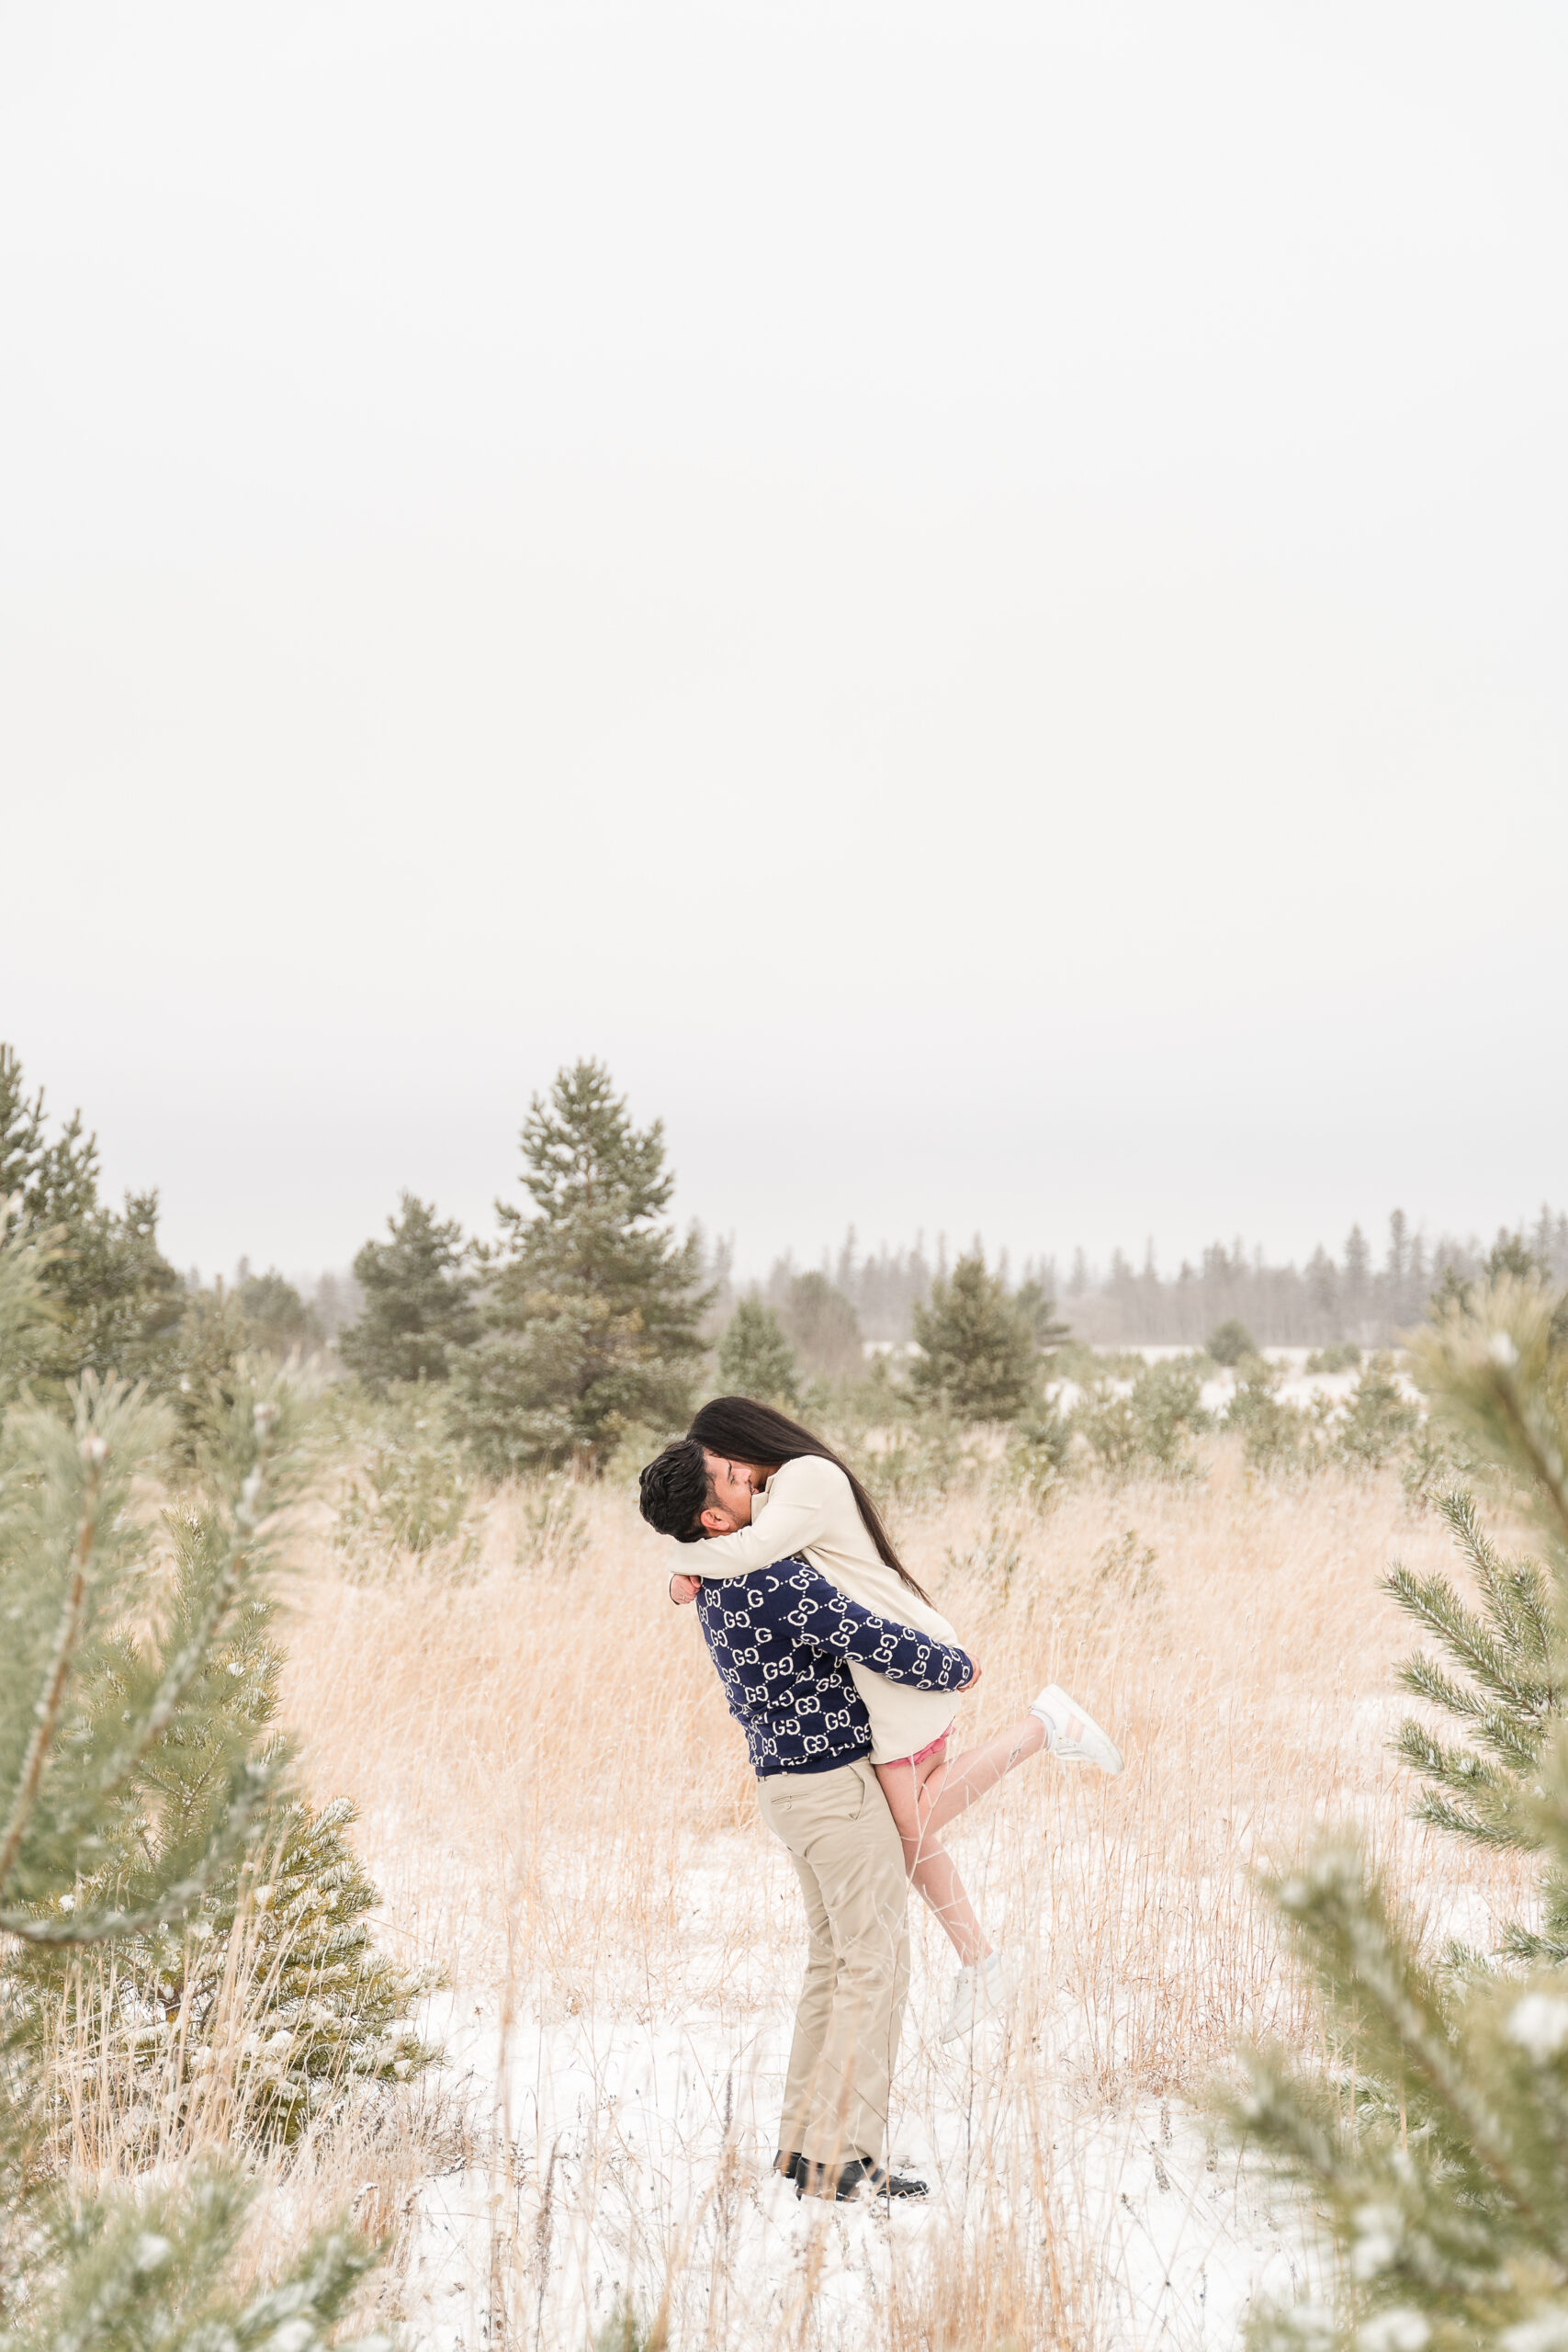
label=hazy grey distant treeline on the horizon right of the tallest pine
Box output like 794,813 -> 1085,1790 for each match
712,1206 -> 1568,1352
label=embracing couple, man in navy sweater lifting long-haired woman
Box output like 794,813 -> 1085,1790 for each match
642,1397 -> 1122,2199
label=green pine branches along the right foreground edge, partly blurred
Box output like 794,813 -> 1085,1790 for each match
1235,1272 -> 1568,2352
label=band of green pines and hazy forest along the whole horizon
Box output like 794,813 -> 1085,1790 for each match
15,1011 -> 1568,1479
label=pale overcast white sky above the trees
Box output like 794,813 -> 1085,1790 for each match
0,0 -> 1568,1270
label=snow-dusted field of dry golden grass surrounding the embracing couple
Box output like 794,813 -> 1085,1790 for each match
39,1446 -> 1528,2352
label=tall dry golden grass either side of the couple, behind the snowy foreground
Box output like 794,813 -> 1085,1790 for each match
285,1456 -> 1517,2060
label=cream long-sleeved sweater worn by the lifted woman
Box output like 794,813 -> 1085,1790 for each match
691,1453 -> 962,1764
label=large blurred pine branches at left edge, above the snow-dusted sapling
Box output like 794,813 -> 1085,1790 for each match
0,1374 -> 296,1948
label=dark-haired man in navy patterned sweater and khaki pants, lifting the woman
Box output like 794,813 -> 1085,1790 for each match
642,1437 -> 976,2201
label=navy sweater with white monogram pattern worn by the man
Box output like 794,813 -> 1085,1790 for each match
696,1557 -> 974,1778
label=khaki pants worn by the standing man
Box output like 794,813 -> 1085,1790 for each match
757,1761 -> 909,2166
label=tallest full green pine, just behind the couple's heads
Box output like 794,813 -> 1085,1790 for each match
451,1061 -> 710,1477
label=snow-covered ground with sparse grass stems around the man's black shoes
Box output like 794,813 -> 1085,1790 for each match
394,2007 -> 1314,2352
